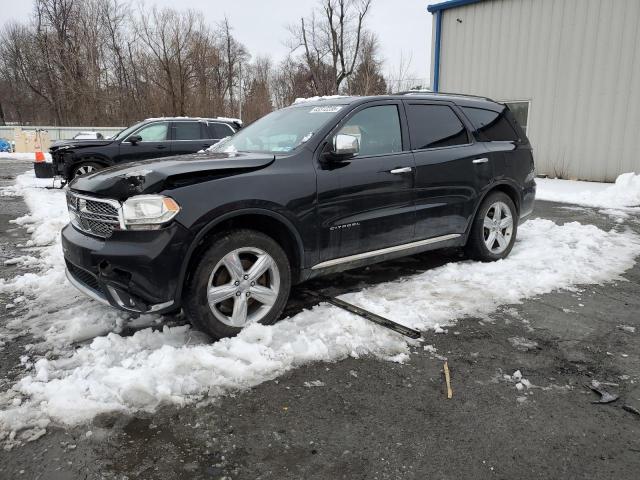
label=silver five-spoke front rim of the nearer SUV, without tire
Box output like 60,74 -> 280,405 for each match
207,247 -> 280,328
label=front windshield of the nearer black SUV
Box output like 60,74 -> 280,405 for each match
210,105 -> 344,153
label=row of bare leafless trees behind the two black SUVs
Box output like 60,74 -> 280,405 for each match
0,0 -> 381,126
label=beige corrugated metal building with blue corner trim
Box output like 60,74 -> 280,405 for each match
428,0 -> 640,181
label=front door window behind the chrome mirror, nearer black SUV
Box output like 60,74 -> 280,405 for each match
338,105 -> 402,156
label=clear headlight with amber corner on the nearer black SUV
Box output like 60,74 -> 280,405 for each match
122,195 -> 180,230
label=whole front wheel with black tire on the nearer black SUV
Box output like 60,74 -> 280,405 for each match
183,229 -> 291,340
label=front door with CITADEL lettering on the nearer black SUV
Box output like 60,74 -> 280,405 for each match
316,101 -> 415,262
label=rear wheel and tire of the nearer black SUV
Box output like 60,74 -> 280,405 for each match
465,192 -> 518,262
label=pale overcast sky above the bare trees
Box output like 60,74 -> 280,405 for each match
0,0 -> 431,85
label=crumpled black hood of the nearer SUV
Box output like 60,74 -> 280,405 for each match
69,152 -> 275,201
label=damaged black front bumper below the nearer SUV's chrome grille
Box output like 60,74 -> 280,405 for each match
61,222 -> 191,313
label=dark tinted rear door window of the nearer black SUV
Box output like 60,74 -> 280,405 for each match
407,104 -> 469,150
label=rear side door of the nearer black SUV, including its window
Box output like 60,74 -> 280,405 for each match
404,100 -> 493,240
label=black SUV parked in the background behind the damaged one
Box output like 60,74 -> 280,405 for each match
49,117 -> 242,180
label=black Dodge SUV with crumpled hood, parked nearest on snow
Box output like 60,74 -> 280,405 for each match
62,94 -> 536,338
